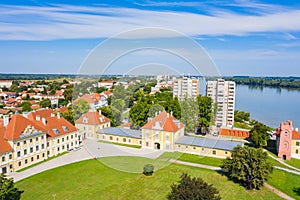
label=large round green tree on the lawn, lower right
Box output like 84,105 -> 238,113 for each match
222,146 -> 273,190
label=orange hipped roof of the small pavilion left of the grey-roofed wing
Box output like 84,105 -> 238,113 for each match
75,111 -> 110,125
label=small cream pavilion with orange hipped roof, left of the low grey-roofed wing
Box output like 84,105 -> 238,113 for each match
75,111 -> 110,139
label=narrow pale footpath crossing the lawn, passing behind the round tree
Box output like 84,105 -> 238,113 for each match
170,160 -> 295,200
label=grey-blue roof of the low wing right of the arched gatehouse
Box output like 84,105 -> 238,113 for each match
175,136 -> 244,150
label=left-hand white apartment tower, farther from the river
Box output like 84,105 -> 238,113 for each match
173,77 -> 200,99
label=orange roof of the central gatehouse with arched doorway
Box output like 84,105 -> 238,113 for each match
142,111 -> 184,132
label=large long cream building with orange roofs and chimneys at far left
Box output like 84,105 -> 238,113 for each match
0,109 -> 79,173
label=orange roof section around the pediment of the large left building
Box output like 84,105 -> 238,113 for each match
4,114 -> 46,140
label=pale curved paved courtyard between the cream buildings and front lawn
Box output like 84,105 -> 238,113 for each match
8,138 -> 163,181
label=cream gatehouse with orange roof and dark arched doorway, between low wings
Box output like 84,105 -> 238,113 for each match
142,112 -> 184,150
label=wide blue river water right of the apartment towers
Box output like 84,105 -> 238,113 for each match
235,85 -> 300,128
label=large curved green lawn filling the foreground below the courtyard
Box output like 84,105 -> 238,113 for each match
16,157 -> 280,200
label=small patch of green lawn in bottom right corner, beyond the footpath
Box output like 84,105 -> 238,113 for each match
268,169 -> 300,199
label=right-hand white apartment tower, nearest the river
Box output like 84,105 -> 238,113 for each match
206,79 -> 235,127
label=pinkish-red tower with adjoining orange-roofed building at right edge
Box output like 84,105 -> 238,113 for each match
276,120 -> 300,160
